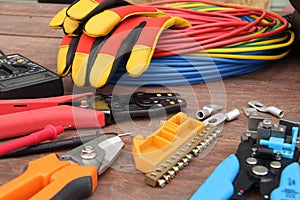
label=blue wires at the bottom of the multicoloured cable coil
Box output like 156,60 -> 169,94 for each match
111,56 -> 270,86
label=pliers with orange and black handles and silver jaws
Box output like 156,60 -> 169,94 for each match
0,134 -> 124,200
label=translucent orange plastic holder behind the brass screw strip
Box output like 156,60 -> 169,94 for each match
132,112 -> 204,173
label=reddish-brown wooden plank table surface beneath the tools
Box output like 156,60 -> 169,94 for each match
0,2 -> 300,200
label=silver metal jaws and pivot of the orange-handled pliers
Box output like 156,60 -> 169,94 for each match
61,135 -> 124,175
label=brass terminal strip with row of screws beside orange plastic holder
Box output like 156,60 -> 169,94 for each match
145,124 -> 221,187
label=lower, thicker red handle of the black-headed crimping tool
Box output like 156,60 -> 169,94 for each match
0,105 -> 105,139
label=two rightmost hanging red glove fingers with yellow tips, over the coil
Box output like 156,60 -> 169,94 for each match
88,17 -> 190,88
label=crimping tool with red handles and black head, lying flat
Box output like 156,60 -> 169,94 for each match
0,92 -> 186,139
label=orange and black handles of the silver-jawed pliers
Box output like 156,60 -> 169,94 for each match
0,154 -> 98,200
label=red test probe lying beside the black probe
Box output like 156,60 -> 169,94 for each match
0,125 -> 65,155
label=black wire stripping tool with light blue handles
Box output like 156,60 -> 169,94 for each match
190,116 -> 300,200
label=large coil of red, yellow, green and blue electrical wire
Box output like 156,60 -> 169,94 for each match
111,0 -> 295,85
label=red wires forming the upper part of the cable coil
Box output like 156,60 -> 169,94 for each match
145,0 -> 288,57
